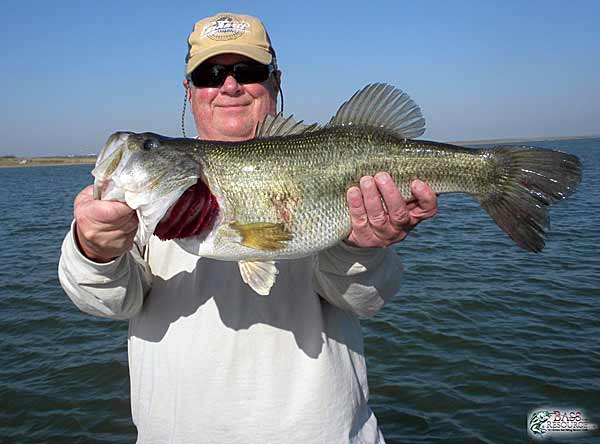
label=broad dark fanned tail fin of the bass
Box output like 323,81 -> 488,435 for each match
475,146 -> 581,253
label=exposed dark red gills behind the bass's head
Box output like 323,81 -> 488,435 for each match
154,180 -> 219,240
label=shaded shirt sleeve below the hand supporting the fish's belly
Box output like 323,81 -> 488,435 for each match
314,242 -> 403,317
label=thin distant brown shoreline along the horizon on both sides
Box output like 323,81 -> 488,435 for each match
0,134 -> 600,168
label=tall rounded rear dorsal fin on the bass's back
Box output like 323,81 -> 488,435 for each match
327,83 -> 425,139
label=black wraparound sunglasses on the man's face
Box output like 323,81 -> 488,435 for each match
191,62 -> 274,88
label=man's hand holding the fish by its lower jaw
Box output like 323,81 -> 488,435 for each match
73,185 -> 138,262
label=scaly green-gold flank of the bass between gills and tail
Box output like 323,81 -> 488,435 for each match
192,127 -> 493,258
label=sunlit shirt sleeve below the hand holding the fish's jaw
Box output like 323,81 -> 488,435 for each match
58,224 -> 152,319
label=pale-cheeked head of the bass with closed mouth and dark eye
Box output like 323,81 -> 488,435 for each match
92,132 -> 200,245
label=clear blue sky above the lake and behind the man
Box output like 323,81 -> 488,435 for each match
0,0 -> 600,155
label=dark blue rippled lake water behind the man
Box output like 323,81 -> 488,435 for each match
0,139 -> 600,444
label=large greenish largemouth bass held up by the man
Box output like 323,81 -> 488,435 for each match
92,84 -> 581,294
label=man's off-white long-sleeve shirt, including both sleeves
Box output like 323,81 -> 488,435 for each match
59,225 -> 401,444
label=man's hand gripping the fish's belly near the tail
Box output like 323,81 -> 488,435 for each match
345,173 -> 437,247
